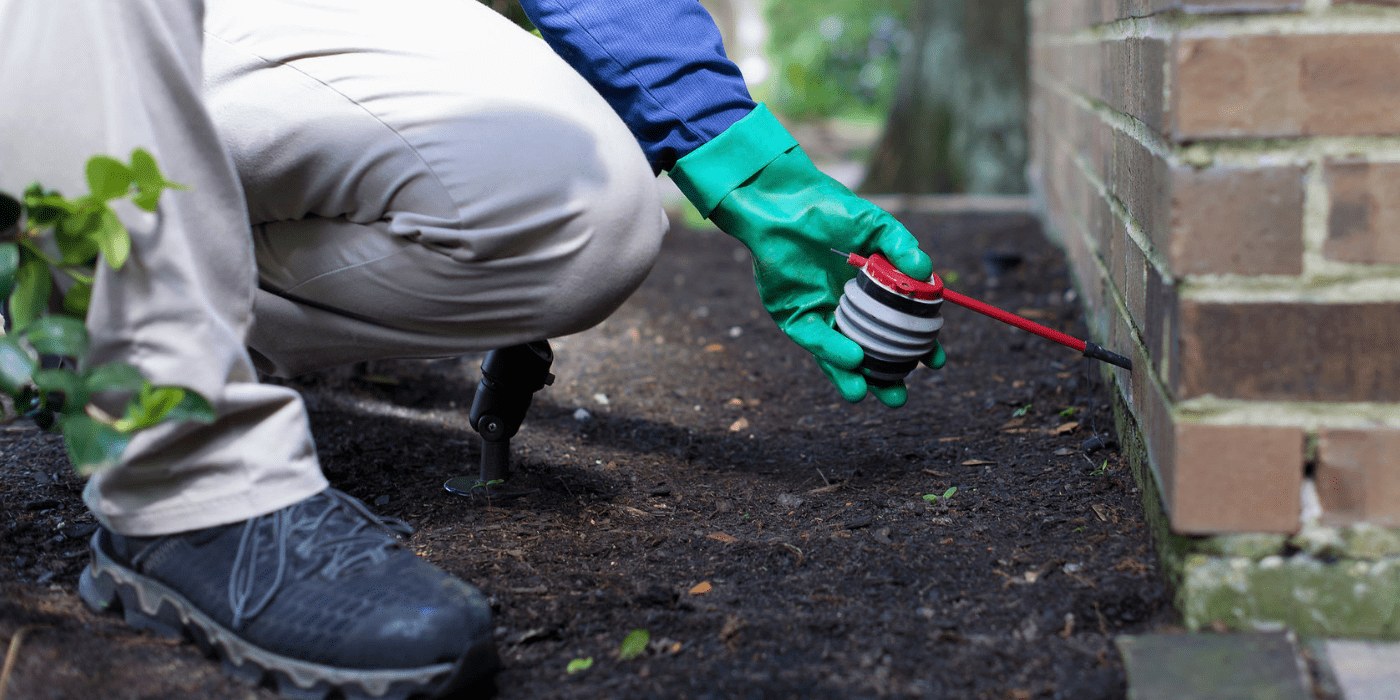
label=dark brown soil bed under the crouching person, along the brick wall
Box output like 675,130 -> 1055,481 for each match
0,216 -> 1170,700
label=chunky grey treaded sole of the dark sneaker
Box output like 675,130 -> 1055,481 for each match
78,531 -> 500,700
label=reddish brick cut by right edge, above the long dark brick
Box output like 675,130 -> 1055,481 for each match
1323,162 -> 1400,265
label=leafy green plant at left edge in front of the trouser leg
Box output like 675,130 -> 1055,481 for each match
0,148 -> 216,475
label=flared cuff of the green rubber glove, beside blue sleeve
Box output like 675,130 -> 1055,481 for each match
671,102 -> 797,218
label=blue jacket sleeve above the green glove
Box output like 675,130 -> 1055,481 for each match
521,0 -> 755,172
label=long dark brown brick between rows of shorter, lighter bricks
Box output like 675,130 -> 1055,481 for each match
1181,297 -> 1400,402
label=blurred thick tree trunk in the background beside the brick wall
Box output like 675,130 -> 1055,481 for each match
861,0 -> 1029,195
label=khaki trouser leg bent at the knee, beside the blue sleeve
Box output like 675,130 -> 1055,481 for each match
204,0 -> 666,375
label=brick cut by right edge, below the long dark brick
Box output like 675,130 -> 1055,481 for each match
1316,428 -> 1400,526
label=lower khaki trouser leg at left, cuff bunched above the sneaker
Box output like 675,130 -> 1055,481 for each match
0,0 -> 326,535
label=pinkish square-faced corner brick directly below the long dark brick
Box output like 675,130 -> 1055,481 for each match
1168,421 -> 1303,535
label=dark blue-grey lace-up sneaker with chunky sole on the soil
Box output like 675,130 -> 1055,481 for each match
78,489 -> 498,700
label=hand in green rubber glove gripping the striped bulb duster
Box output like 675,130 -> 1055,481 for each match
671,105 -> 945,407
